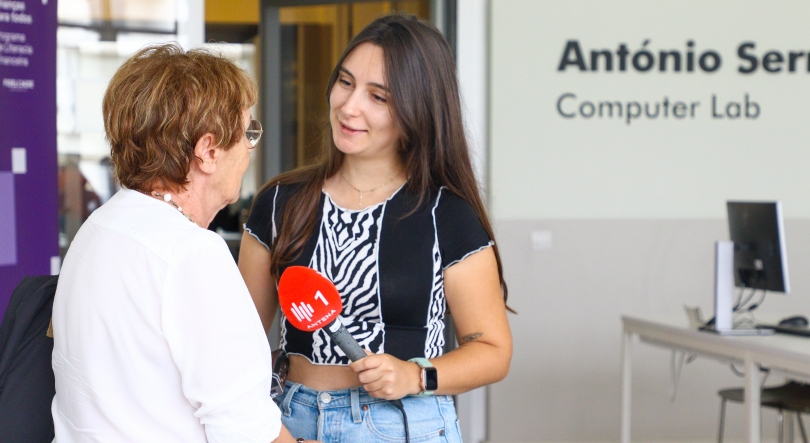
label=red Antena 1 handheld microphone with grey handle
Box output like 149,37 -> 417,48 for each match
278,266 -> 366,361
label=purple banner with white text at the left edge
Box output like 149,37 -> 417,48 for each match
0,0 -> 59,317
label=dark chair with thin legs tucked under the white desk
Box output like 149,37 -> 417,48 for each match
717,381 -> 810,443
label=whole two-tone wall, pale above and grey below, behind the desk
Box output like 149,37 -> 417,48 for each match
488,0 -> 810,442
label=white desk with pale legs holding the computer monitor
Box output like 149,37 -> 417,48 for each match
621,316 -> 810,443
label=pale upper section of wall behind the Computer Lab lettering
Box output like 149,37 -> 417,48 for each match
491,0 -> 810,219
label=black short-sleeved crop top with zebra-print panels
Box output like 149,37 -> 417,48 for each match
245,185 -> 493,365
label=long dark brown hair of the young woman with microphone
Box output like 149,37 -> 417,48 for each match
259,14 -> 508,306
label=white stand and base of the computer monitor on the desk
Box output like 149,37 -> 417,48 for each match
710,241 -> 774,335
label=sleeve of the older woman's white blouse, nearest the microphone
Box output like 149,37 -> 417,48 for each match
162,233 -> 281,443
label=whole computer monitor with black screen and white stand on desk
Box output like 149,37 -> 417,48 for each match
711,201 -> 790,335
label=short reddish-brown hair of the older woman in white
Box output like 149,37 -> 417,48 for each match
102,44 -> 256,192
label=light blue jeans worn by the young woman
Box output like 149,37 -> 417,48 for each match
276,382 -> 461,443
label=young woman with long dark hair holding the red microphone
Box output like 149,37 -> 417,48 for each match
239,15 -> 512,442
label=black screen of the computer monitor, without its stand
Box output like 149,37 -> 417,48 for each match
727,201 -> 790,294
